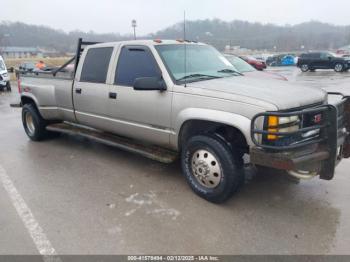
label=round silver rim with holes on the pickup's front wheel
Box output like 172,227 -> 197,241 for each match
191,150 -> 222,188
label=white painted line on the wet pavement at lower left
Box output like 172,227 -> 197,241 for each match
0,166 -> 61,262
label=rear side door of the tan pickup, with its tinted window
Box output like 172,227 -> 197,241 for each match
73,47 -> 113,130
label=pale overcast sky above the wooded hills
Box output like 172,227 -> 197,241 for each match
0,0 -> 350,34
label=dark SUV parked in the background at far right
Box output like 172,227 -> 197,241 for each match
297,52 -> 350,72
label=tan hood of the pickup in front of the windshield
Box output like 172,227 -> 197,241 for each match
187,76 -> 327,110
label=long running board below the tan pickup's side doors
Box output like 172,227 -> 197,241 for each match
46,122 -> 177,163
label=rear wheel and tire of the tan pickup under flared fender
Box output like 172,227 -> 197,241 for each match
22,104 -> 48,141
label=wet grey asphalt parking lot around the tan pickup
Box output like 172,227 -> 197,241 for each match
0,68 -> 350,255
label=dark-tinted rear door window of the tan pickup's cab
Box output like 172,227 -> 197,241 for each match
80,47 -> 113,83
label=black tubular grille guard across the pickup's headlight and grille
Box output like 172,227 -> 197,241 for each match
251,92 -> 350,151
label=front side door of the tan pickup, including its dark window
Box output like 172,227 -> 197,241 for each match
110,45 -> 172,145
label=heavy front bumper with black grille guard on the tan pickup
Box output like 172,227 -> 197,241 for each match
250,93 -> 350,180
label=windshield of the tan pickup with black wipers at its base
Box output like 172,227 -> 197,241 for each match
155,44 -> 238,82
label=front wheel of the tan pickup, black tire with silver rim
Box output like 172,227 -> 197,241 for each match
181,135 -> 244,203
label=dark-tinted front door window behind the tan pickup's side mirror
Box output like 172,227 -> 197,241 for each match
114,46 -> 161,86
